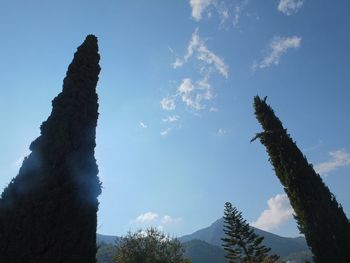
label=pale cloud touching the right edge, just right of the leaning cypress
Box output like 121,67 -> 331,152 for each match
314,149 -> 350,175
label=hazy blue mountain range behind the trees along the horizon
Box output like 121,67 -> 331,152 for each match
97,218 -> 312,263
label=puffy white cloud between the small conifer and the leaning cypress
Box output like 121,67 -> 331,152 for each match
251,194 -> 293,231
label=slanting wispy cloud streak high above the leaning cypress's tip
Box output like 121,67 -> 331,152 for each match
252,36 -> 301,70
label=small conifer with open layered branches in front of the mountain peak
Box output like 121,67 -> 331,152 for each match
221,202 -> 278,263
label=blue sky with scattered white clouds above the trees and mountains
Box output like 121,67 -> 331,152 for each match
0,0 -> 350,239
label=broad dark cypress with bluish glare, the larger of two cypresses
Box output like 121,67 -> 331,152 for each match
0,35 -> 101,263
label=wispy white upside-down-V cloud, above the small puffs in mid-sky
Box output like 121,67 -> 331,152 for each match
172,28 -> 229,78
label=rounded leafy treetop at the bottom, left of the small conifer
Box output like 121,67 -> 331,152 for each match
114,228 -> 190,263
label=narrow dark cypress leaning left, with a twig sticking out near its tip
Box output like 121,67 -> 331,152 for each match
253,96 -> 350,263
